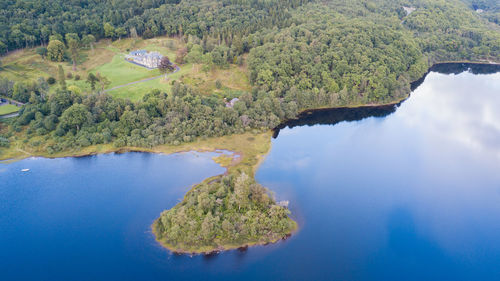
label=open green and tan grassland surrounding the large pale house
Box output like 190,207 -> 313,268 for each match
0,37 -> 251,101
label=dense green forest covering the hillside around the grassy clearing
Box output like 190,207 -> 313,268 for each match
0,0 -> 500,153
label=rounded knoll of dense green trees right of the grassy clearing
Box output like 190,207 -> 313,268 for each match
249,10 -> 426,102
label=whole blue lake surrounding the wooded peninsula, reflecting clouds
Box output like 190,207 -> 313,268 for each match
0,65 -> 500,280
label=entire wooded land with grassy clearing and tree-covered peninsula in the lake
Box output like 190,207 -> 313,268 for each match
0,0 -> 500,253
